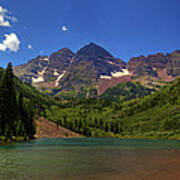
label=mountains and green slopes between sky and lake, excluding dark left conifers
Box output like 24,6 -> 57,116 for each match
1,43 -> 180,141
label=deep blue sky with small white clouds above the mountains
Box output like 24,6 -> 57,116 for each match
0,0 -> 180,67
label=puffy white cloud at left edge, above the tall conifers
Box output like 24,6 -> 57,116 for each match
0,33 -> 20,52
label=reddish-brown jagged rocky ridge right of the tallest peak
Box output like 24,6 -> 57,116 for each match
127,51 -> 180,86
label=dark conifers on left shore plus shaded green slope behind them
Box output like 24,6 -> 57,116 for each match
0,63 -> 56,141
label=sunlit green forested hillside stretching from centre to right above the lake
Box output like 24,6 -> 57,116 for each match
42,79 -> 180,138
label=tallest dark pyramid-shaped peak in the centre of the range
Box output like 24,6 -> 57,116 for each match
60,43 -> 129,90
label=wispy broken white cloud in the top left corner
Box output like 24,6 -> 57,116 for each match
0,6 -> 17,27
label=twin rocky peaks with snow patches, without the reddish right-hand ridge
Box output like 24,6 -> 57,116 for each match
14,43 -> 129,96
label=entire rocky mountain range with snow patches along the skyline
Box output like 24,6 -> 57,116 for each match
14,43 -> 180,97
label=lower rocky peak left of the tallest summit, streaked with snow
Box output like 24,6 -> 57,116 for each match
14,48 -> 74,89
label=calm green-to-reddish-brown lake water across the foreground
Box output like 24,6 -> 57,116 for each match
0,138 -> 180,180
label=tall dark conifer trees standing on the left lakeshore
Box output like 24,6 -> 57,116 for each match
0,63 -> 35,141
